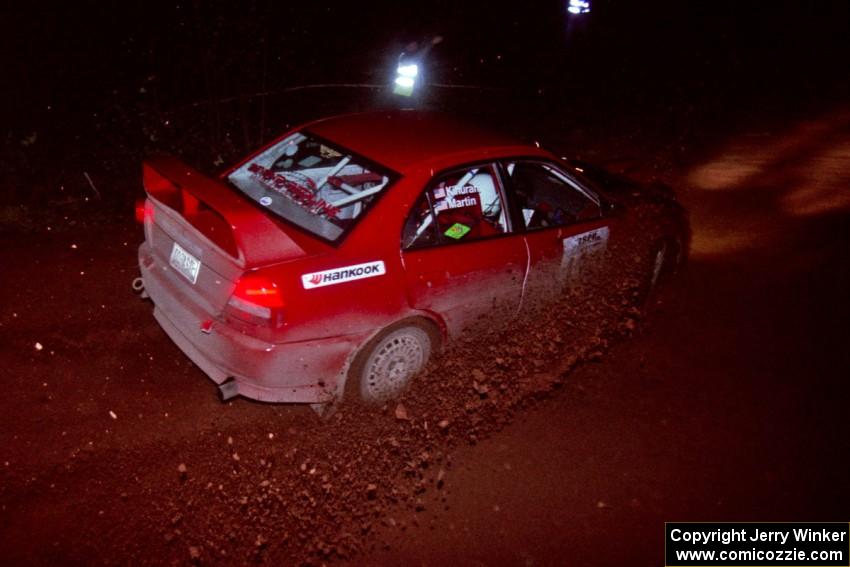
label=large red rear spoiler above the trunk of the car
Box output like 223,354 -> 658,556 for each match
142,156 -> 304,267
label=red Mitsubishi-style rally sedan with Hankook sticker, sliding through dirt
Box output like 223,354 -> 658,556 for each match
139,111 -> 687,404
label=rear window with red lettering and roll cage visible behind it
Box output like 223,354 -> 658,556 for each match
227,132 -> 395,242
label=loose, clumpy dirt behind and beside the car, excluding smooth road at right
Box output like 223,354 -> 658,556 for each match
3,202 -> 649,564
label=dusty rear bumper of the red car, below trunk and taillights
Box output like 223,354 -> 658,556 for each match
139,244 -> 365,403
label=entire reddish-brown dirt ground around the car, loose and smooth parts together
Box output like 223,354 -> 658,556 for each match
0,105 -> 850,565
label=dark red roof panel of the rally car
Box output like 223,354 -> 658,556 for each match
305,110 -> 533,172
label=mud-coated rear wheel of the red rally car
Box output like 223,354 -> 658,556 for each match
347,323 -> 435,404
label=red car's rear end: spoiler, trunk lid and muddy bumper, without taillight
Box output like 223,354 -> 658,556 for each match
139,156 -> 356,402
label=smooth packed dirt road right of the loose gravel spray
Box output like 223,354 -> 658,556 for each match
365,111 -> 850,565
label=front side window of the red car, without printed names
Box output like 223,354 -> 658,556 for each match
506,161 -> 600,230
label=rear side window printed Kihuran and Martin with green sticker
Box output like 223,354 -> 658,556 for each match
402,165 -> 510,248
